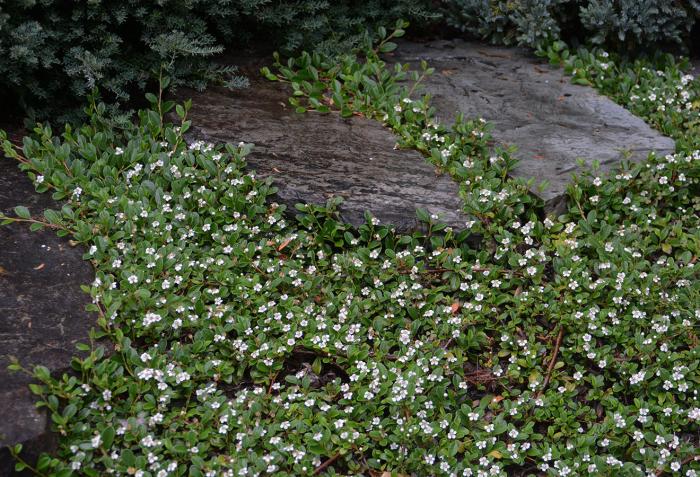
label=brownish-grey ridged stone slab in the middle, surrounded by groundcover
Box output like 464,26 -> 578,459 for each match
179,58 -> 468,232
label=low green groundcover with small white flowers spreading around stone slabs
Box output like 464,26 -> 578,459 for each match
3,24 -> 700,477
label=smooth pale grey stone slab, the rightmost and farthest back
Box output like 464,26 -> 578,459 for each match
390,40 -> 675,208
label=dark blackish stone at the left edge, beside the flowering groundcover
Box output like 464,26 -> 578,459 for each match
0,156 -> 95,476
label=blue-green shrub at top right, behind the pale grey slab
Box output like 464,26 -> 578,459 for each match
446,0 -> 700,52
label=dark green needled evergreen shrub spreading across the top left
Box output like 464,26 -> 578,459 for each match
0,0 -> 432,116
